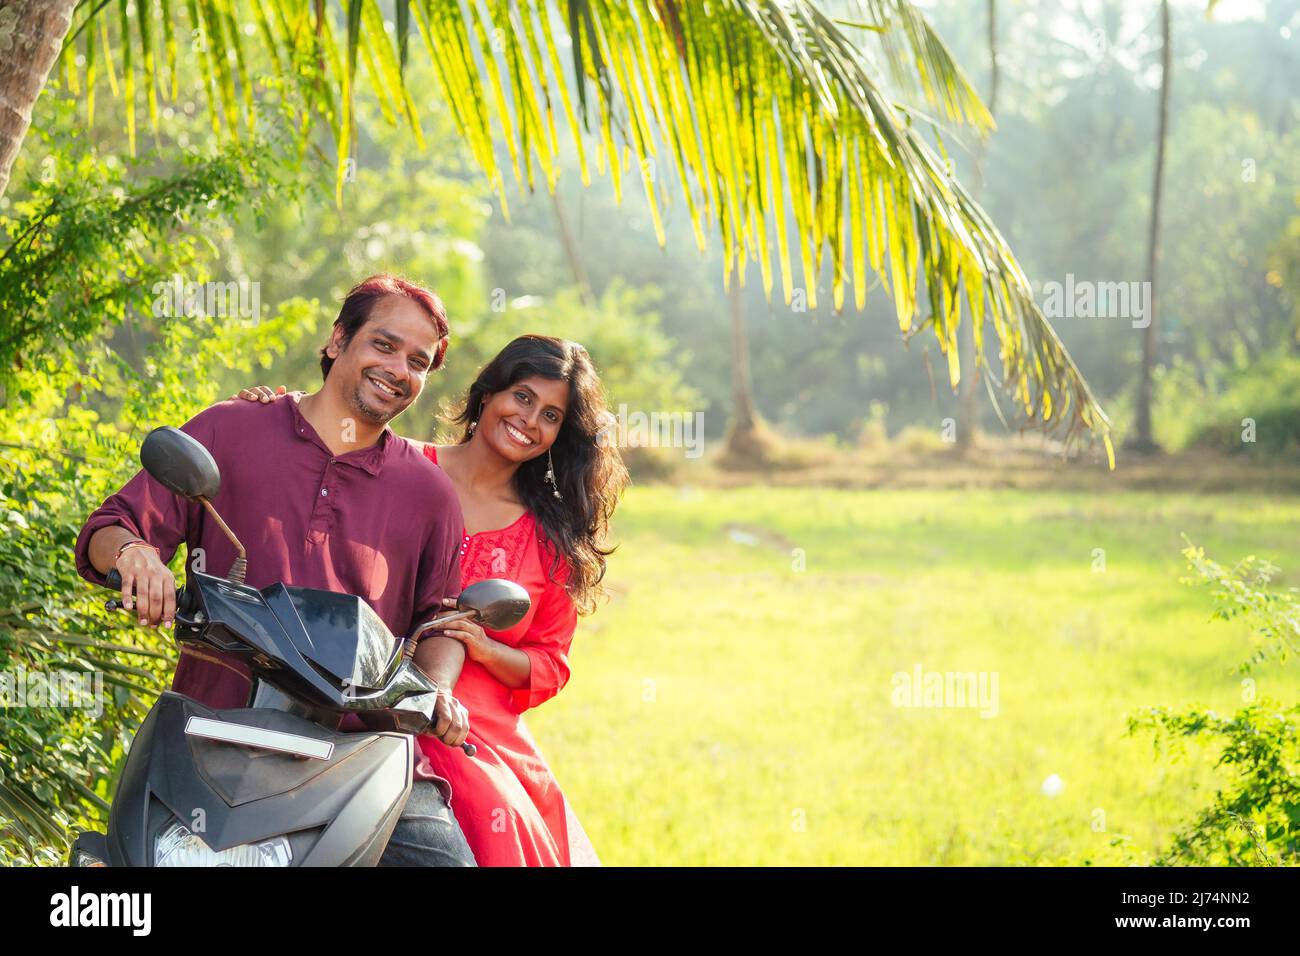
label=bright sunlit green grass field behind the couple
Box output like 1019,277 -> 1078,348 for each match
528,486 -> 1300,865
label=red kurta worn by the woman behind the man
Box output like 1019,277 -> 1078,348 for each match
419,445 -> 594,866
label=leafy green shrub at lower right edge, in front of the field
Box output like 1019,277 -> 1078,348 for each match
1128,544 -> 1300,866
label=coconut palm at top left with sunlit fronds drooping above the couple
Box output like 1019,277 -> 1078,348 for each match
0,0 -> 1110,454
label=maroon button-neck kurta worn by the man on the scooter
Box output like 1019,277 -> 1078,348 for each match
77,392 -> 464,779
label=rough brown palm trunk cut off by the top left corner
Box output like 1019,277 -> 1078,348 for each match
0,0 -> 77,196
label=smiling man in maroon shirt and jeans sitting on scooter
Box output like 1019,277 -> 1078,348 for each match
77,274 -> 475,866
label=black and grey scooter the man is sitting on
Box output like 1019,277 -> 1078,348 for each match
69,427 -> 529,866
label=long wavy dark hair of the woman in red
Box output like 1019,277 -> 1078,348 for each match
452,336 -> 628,614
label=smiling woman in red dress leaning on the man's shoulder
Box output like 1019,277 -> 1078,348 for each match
239,336 -> 628,866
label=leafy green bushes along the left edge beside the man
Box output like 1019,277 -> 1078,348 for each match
0,130 -> 316,864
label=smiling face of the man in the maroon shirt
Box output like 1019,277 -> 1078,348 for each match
325,295 -> 438,425
